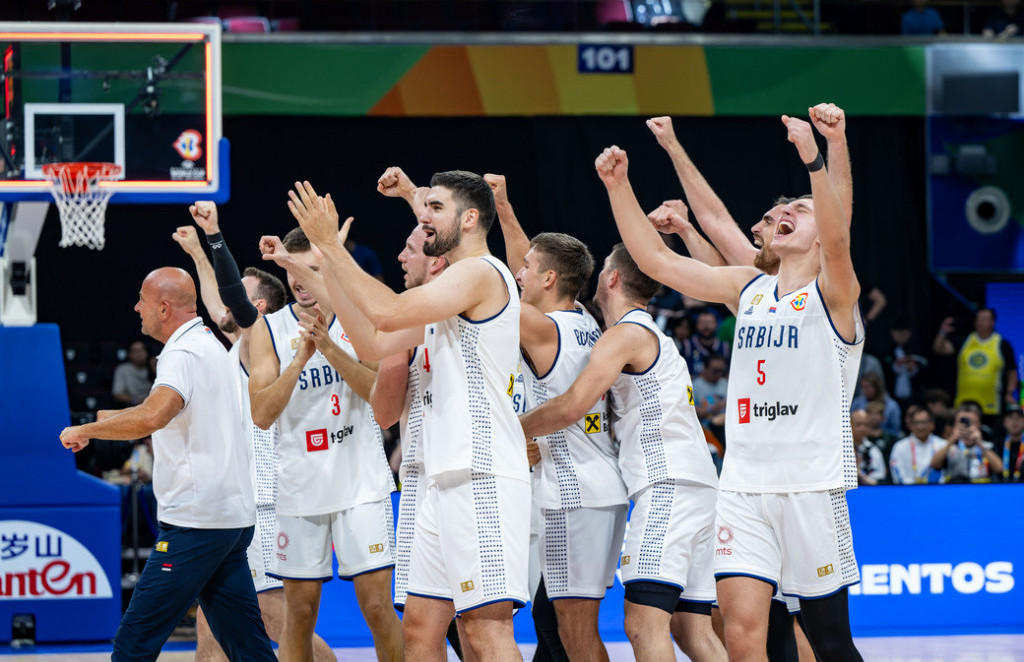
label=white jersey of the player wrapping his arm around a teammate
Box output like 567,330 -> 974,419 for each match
611,308 -> 718,498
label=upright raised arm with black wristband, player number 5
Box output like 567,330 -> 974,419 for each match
782,113 -> 860,340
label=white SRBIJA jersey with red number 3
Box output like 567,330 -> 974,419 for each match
263,303 -> 394,516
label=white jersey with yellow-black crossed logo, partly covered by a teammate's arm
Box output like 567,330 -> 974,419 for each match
523,307 -> 629,510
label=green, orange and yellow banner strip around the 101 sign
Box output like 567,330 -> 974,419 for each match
223,43 -> 925,117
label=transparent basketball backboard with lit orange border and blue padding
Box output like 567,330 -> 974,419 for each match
0,23 -> 230,204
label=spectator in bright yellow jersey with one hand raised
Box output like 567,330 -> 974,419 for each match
932,308 -> 1017,432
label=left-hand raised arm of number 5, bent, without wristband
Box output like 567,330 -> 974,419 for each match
595,146 -> 759,305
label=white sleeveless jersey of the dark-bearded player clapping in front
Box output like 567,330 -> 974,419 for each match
423,255 -> 529,481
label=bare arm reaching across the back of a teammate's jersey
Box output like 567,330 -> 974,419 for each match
519,324 -> 638,439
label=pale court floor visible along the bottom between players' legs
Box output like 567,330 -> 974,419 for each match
0,634 -> 1024,662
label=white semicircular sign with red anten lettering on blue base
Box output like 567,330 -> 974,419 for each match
0,520 -> 112,601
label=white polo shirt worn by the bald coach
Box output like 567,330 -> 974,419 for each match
153,318 -> 256,529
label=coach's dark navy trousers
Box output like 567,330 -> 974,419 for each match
111,523 -> 276,662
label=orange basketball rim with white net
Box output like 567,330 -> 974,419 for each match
43,162 -> 121,250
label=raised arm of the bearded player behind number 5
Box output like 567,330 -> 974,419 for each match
647,117 -> 758,266
